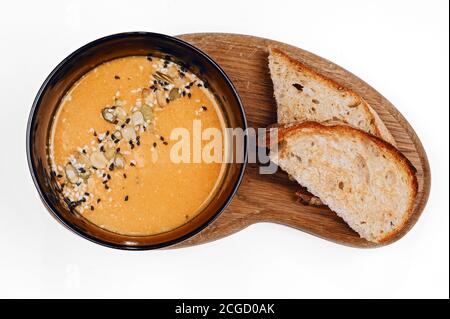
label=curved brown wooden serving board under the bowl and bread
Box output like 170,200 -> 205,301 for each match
175,33 -> 430,247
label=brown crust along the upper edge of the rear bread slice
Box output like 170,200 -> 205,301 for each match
269,46 -> 396,146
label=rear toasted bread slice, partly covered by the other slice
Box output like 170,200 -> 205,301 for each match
269,48 -> 395,146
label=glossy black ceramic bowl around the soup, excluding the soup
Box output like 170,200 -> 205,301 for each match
27,32 -> 247,250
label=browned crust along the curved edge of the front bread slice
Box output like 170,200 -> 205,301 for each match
270,121 -> 418,243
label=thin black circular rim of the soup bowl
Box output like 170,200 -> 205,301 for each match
26,31 -> 248,251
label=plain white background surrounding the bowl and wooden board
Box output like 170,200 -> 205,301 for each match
0,0 -> 449,298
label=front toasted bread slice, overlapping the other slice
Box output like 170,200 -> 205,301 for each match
269,122 -> 417,243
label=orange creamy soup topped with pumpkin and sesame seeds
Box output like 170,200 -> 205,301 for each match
49,56 -> 226,235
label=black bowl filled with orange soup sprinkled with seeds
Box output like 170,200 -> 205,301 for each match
27,32 -> 247,249
